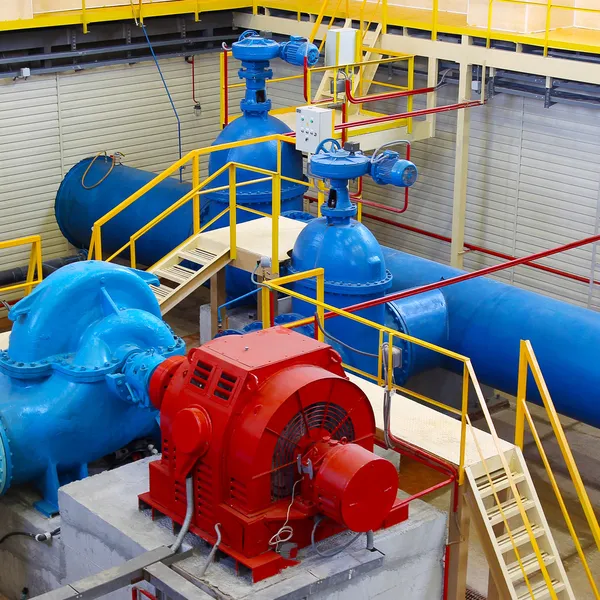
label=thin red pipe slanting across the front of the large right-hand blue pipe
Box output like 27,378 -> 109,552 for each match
325,235 -> 600,319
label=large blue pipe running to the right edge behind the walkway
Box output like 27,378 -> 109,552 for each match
383,247 -> 600,427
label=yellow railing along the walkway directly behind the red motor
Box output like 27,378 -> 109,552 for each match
261,268 -> 479,484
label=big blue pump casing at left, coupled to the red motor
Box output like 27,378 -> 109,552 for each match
0,261 -> 185,514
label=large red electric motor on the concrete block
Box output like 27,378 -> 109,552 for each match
140,327 -> 408,581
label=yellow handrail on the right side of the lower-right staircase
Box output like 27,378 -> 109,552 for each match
515,341 -> 600,600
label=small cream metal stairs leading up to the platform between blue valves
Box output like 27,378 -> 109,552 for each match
148,234 -> 231,315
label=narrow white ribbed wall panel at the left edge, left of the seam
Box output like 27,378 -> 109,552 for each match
0,75 -> 68,278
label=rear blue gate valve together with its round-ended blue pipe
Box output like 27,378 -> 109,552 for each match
55,31 -> 319,270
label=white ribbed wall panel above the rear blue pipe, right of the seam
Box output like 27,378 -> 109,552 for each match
60,52 -> 240,178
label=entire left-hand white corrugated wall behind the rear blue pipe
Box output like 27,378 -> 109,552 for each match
0,52 -> 239,276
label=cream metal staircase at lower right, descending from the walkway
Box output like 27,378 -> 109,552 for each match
465,447 -> 575,600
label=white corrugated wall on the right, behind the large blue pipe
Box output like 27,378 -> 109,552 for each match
273,64 -> 600,309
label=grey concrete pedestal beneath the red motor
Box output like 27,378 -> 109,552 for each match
59,459 -> 446,600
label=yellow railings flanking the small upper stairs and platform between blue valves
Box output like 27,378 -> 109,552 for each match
89,135 -> 311,275
